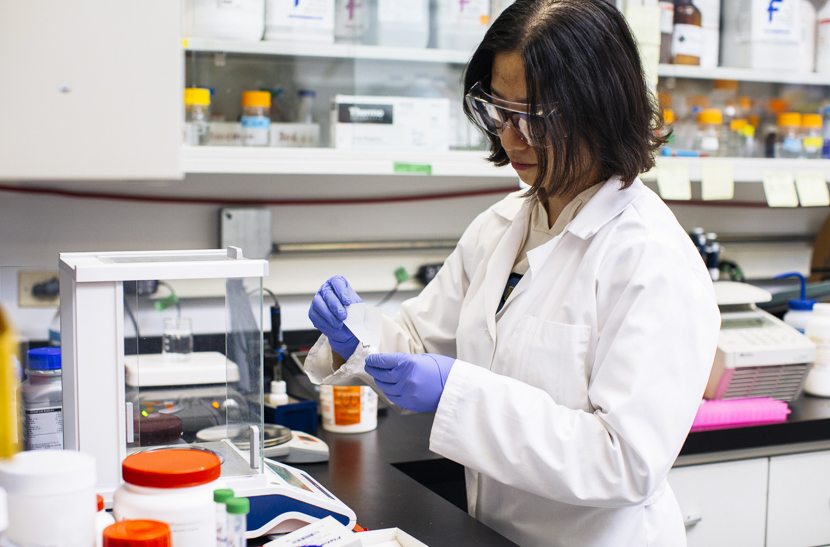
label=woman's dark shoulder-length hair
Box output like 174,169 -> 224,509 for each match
464,0 -> 665,199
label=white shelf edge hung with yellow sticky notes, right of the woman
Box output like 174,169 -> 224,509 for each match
641,157 -> 830,182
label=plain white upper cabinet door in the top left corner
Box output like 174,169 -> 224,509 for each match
0,0 -> 184,180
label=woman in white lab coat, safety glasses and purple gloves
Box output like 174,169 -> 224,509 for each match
309,0 -> 720,546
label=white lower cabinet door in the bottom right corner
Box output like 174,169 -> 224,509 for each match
767,452 -> 830,547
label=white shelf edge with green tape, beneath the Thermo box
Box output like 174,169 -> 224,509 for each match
182,146 -> 518,180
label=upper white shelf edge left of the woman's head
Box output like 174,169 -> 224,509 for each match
183,38 -> 472,64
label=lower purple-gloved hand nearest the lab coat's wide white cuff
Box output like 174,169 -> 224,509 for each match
366,353 -> 455,412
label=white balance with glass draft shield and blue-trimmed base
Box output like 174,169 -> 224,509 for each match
59,247 -> 356,538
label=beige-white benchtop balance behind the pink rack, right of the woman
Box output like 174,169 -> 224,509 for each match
704,281 -> 816,401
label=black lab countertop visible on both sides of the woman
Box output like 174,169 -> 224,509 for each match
297,395 -> 830,547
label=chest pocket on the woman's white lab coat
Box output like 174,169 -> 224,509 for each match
512,315 -> 591,409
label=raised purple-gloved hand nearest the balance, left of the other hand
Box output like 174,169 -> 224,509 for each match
308,275 -> 363,361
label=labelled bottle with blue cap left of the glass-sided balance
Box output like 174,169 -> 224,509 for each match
20,347 -> 63,450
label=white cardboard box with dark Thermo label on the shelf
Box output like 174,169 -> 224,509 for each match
331,95 -> 450,151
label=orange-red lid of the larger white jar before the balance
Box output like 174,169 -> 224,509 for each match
121,449 -> 221,488
